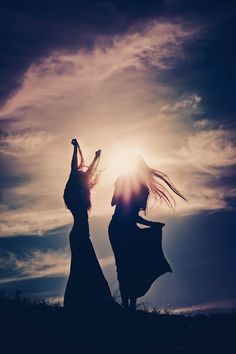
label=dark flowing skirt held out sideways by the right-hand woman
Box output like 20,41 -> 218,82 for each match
109,219 -> 172,298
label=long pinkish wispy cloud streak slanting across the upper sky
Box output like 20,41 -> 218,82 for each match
1,22 -> 194,119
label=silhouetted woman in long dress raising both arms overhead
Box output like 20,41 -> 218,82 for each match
64,139 -> 111,312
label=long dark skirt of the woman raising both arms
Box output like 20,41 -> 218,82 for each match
64,219 -> 112,312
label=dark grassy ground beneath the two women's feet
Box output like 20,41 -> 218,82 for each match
0,298 -> 236,354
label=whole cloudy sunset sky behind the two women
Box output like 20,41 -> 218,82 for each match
0,0 -> 236,311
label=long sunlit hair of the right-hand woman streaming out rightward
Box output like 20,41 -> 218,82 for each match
137,157 -> 187,210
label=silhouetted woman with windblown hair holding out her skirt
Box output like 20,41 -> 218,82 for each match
109,157 -> 185,309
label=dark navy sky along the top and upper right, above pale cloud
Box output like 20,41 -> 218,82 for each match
0,0 -> 235,115
